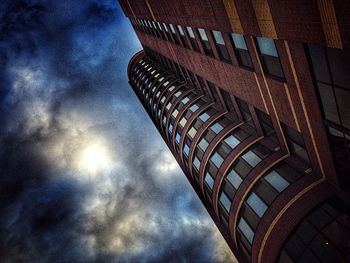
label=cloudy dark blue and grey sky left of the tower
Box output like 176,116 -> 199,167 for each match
0,0 -> 237,263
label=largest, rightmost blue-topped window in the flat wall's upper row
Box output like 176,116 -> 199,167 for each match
256,37 -> 284,79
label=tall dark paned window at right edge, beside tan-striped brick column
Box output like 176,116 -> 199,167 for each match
308,45 -> 350,192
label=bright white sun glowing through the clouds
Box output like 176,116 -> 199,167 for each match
78,143 -> 111,175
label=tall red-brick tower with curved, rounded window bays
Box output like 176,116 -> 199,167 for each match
120,0 -> 350,263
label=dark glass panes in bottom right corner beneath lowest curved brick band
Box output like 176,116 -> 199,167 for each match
278,197 -> 350,263
